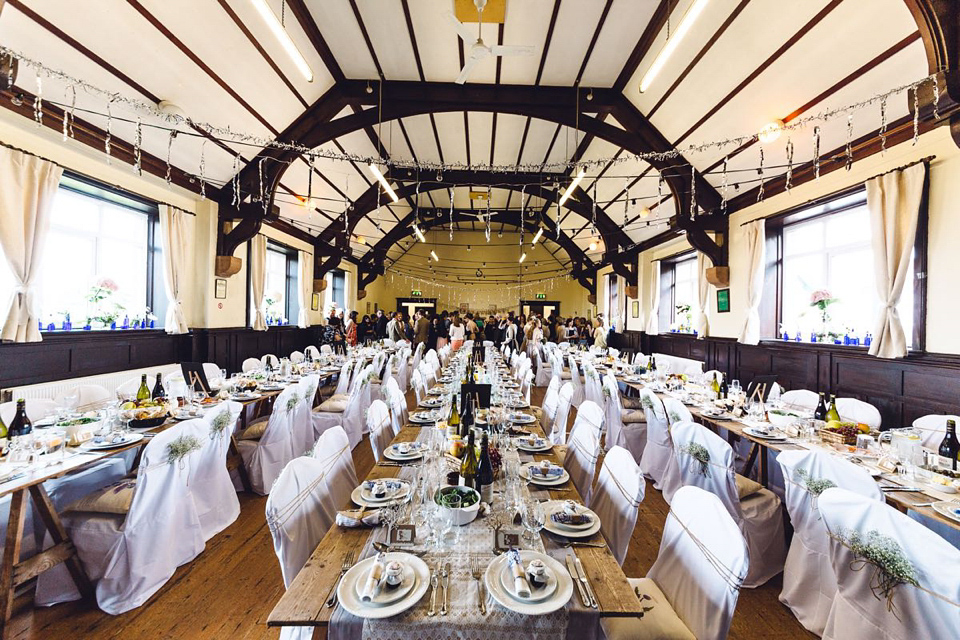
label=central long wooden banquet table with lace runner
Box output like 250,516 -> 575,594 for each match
267,416 -> 642,639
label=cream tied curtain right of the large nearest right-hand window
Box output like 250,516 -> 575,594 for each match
866,163 -> 926,358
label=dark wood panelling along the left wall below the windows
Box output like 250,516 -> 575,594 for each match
0,327 -> 320,389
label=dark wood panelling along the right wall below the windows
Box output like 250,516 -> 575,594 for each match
618,331 -> 960,429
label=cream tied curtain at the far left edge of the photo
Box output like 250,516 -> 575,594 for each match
0,147 -> 63,342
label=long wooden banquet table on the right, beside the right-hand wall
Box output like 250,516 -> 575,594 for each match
617,376 -> 960,531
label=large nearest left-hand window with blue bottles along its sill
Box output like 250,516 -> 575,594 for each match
0,174 -> 163,330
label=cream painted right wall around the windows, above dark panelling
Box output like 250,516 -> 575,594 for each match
640,127 -> 960,353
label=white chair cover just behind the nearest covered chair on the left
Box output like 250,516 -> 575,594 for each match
188,400 -> 243,540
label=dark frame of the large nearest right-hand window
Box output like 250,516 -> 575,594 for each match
760,180 -> 930,353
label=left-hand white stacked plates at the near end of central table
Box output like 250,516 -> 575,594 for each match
337,551 -> 430,618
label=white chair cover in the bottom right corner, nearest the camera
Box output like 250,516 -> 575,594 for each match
817,488 -> 960,640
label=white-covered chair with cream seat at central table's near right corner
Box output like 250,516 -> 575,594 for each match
600,487 -> 751,640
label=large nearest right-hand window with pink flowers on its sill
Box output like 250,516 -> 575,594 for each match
763,189 -> 926,347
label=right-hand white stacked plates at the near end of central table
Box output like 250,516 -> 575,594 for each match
483,551 -> 573,615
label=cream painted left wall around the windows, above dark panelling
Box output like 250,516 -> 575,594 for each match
0,109 -> 330,328
